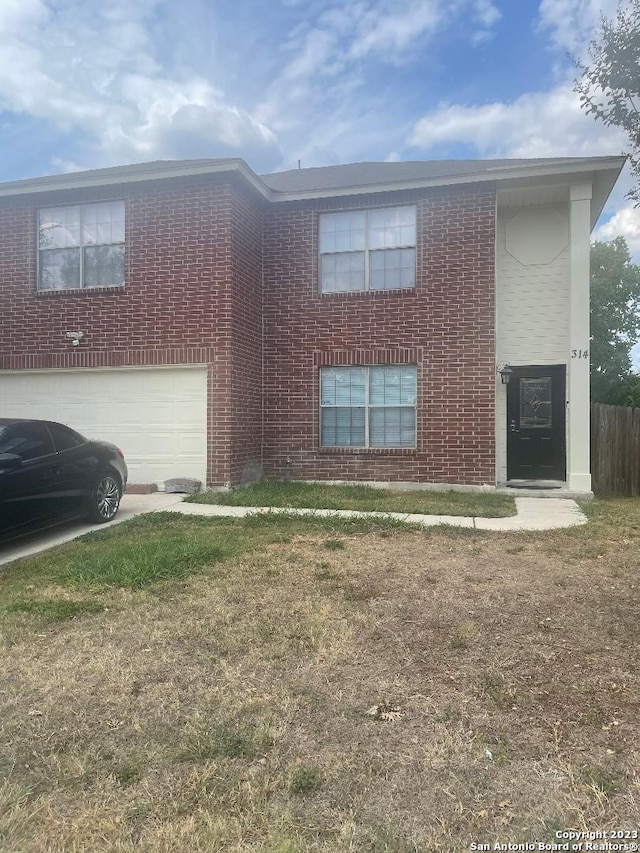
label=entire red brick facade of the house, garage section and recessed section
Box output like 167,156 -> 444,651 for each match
0,171 -> 495,485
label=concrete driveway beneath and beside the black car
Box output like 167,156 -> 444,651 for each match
0,492 -> 184,565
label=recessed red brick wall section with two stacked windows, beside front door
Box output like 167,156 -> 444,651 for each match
264,185 -> 495,484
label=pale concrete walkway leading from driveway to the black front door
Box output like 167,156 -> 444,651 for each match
162,498 -> 587,530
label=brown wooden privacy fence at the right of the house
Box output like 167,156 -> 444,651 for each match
591,403 -> 640,496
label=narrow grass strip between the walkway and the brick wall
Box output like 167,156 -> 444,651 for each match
187,480 -> 516,518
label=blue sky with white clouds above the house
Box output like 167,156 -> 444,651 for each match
0,0 -> 640,362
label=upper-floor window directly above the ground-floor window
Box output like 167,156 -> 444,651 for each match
320,206 -> 416,293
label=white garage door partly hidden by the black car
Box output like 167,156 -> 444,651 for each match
0,367 -> 207,483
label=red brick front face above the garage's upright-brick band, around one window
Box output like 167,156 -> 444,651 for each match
0,173 -> 232,360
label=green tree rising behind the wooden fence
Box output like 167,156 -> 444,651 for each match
591,237 -> 640,405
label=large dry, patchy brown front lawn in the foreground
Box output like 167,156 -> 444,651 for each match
0,499 -> 640,853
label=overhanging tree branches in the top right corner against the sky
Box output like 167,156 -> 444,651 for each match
575,0 -> 640,204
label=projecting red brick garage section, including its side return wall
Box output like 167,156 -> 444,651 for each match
0,176 -> 261,484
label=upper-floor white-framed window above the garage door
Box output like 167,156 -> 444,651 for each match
38,201 -> 124,290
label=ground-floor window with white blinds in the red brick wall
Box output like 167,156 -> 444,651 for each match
320,364 -> 416,447
